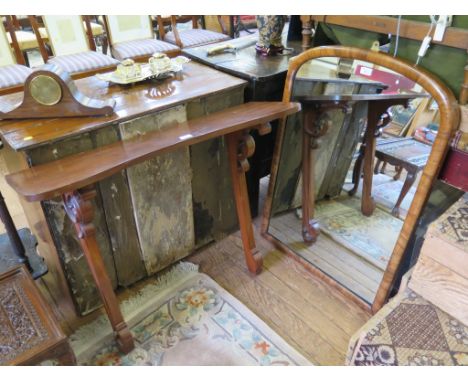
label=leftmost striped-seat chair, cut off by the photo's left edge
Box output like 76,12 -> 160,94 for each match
0,16 -> 32,94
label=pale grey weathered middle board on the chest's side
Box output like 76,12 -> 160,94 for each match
119,106 -> 195,274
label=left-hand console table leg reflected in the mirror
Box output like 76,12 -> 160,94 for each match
302,108 -> 320,244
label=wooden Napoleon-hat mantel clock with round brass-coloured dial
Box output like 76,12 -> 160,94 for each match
0,64 -> 115,119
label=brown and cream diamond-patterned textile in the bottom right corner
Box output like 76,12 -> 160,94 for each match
347,289 -> 468,366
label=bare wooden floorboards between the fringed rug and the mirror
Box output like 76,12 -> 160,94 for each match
187,228 -> 370,365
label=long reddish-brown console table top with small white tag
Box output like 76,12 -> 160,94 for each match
6,102 -> 300,201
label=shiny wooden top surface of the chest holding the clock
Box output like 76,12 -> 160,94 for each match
0,62 -> 246,150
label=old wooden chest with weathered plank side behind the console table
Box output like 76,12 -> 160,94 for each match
0,62 -> 254,318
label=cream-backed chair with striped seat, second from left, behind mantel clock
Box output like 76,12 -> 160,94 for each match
29,16 -> 118,79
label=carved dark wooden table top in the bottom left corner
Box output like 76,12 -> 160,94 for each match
0,265 -> 76,365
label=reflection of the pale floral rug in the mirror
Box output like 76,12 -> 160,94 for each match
315,196 -> 403,270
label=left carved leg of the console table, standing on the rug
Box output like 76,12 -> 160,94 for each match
63,186 -> 134,353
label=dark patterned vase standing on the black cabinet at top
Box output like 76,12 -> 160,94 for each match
255,16 -> 285,56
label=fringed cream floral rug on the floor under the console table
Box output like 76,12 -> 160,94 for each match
70,263 -> 311,366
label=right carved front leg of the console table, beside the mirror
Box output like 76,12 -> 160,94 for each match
226,131 -> 263,274
